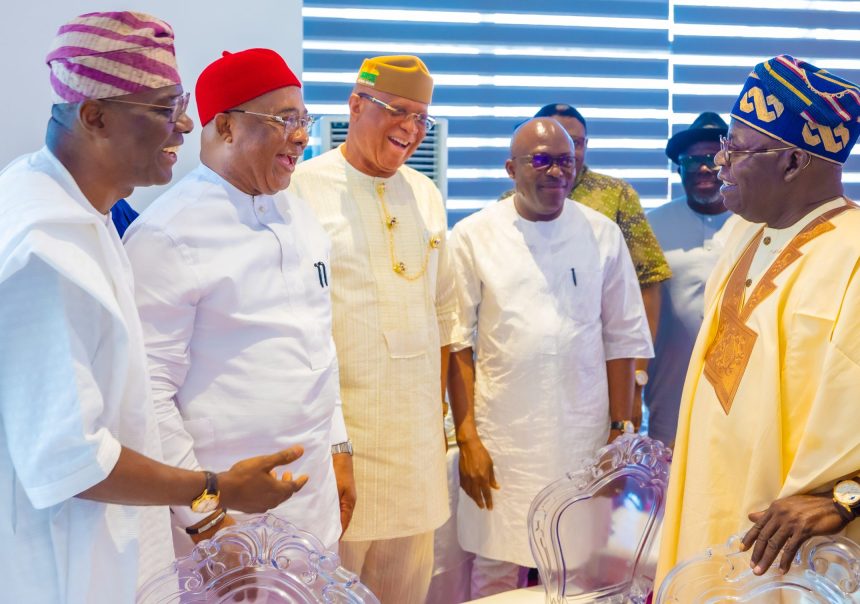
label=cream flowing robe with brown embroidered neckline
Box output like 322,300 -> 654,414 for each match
658,200 -> 860,578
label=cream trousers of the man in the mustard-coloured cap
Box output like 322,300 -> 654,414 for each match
340,531 -> 433,604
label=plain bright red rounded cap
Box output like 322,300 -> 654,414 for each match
194,48 -> 302,126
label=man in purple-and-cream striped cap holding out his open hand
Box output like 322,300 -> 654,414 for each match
0,12 -> 306,604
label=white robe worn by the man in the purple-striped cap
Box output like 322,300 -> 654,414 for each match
0,149 -> 173,604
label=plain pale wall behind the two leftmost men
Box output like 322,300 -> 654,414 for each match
0,0 -> 302,209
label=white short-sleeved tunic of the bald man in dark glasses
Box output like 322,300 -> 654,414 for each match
451,197 -> 653,566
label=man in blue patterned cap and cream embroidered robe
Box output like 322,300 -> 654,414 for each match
658,55 -> 860,578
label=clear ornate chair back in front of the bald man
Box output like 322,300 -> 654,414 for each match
529,434 -> 671,604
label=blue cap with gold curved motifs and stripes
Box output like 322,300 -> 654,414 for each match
732,55 -> 860,164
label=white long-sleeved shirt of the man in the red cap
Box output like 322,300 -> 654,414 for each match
124,165 -> 347,551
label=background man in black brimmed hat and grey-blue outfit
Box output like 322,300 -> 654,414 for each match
645,111 -> 731,446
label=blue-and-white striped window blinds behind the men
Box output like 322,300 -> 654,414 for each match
303,0 -> 860,225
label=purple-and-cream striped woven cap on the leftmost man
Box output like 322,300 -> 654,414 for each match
45,12 -> 180,104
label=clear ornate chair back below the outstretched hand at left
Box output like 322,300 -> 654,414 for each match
137,514 -> 379,604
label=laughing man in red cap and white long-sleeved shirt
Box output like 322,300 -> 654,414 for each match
125,48 -> 355,553
